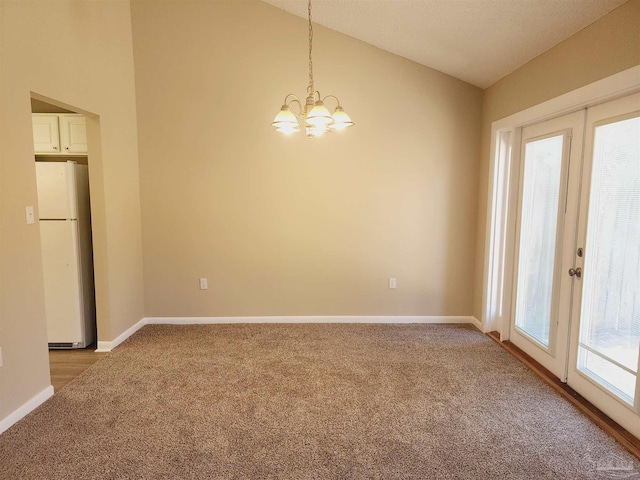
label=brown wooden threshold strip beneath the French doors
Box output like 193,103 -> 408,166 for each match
487,332 -> 640,459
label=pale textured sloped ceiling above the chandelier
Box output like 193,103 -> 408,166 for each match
263,0 -> 626,88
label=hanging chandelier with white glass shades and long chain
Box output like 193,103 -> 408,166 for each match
271,0 -> 353,138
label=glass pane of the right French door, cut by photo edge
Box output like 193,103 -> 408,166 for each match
578,117 -> 640,404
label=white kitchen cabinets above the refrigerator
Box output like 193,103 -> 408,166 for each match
31,113 -> 87,155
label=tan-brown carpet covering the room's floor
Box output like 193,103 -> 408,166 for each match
0,324 -> 640,480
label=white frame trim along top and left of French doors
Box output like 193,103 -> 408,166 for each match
480,65 -> 640,340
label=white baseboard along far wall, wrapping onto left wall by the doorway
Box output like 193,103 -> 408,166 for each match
96,315 -> 482,352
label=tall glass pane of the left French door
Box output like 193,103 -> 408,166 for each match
516,135 -> 563,347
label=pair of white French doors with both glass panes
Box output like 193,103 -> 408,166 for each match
510,94 -> 640,437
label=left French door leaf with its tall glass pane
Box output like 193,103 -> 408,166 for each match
510,111 -> 584,381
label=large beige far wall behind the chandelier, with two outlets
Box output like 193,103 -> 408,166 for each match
132,1 -> 482,316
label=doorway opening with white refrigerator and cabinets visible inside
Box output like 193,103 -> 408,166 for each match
31,98 -> 97,349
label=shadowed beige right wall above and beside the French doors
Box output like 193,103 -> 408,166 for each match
473,0 -> 640,318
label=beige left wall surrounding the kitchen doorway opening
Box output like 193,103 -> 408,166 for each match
0,0 -> 144,420
